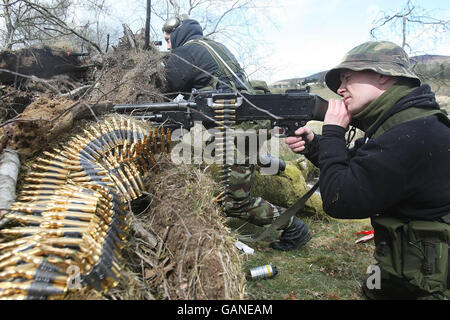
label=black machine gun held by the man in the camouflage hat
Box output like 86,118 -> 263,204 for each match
114,90 -> 328,136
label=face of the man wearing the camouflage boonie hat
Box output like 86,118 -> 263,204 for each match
337,69 -> 386,115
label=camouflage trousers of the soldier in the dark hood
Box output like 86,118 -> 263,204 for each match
222,164 -> 292,229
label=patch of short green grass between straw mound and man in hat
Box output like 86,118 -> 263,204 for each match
230,218 -> 374,300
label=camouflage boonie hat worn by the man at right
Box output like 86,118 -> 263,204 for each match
325,41 -> 420,92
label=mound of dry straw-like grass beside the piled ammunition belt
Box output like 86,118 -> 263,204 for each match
106,155 -> 245,300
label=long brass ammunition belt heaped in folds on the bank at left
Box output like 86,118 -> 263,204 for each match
0,117 -> 171,299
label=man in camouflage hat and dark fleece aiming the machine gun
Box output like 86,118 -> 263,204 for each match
286,41 -> 450,299
